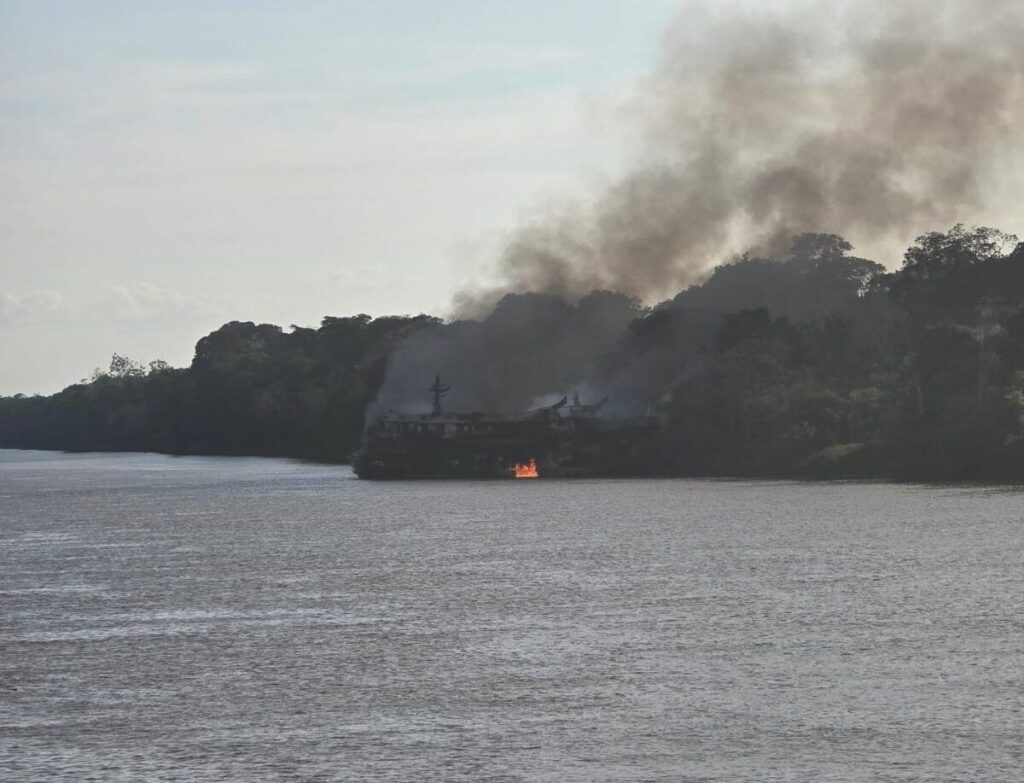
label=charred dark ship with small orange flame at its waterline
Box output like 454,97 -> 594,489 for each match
352,376 -> 659,479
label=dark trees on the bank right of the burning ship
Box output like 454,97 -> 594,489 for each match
632,226 -> 1024,481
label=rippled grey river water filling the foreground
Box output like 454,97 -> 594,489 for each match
0,451 -> 1024,782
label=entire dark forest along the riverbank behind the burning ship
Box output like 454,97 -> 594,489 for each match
0,226 -> 1024,481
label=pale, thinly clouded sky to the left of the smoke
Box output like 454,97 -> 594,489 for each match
0,0 -> 677,394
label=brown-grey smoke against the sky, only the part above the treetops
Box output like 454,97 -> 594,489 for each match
456,0 -> 1024,314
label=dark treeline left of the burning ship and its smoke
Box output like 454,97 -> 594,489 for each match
0,315 -> 438,461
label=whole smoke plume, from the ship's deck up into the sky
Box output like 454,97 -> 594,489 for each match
375,0 -> 1024,411
